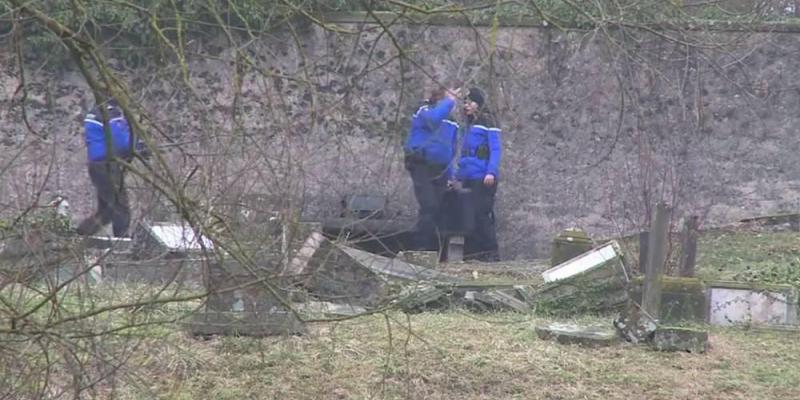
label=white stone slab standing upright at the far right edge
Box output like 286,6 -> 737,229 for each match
708,287 -> 794,326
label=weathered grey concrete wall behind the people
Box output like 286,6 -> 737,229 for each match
0,24 -> 800,257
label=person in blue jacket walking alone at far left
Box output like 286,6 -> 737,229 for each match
77,99 -> 134,237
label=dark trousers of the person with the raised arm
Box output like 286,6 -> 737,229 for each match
405,155 -> 447,251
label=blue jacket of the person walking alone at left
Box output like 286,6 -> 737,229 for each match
83,107 -> 133,162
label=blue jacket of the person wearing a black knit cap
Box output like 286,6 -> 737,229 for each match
456,117 -> 503,180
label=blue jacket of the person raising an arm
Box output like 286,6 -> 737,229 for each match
404,98 -> 458,166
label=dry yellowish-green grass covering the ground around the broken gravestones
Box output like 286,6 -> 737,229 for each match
0,223 -> 800,400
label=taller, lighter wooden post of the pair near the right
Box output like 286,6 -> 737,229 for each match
642,202 -> 670,321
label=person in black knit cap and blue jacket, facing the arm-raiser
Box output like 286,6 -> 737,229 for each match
456,88 -> 502,261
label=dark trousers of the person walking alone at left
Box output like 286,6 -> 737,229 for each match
78,161 -> 131,237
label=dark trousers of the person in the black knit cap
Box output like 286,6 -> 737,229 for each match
462,179 -> 499,261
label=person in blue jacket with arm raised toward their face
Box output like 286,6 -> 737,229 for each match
404,89 -> 460,250
